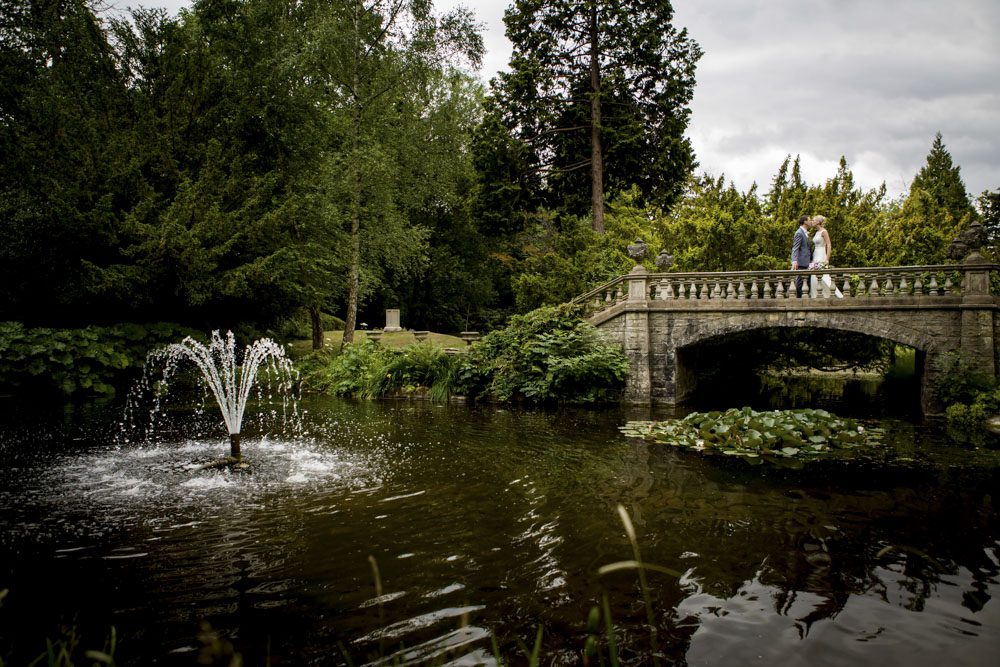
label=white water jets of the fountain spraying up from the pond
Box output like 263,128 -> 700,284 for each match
140,331 -> 297,460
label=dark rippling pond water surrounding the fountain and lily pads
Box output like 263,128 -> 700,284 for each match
0,400 -> 1000,666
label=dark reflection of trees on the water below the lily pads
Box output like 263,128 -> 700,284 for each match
584,443 -> 1000,637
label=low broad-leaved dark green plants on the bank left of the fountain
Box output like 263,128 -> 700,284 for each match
0,322 -> 198,398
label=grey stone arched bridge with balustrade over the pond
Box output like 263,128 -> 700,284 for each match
576,252 -> 1000,414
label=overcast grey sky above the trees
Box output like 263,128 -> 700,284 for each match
129,0 -> 1000,197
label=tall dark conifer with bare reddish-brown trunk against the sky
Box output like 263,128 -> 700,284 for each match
486,0 -> 701,233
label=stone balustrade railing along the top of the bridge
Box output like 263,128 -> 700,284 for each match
575,263 -> 1000,315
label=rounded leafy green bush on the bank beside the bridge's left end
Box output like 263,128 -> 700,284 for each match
456,304 -> 628,403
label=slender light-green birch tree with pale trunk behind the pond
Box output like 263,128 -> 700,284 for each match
298,0 -> 483,343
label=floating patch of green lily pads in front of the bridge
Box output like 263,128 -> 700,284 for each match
620,408 -> 881,460
